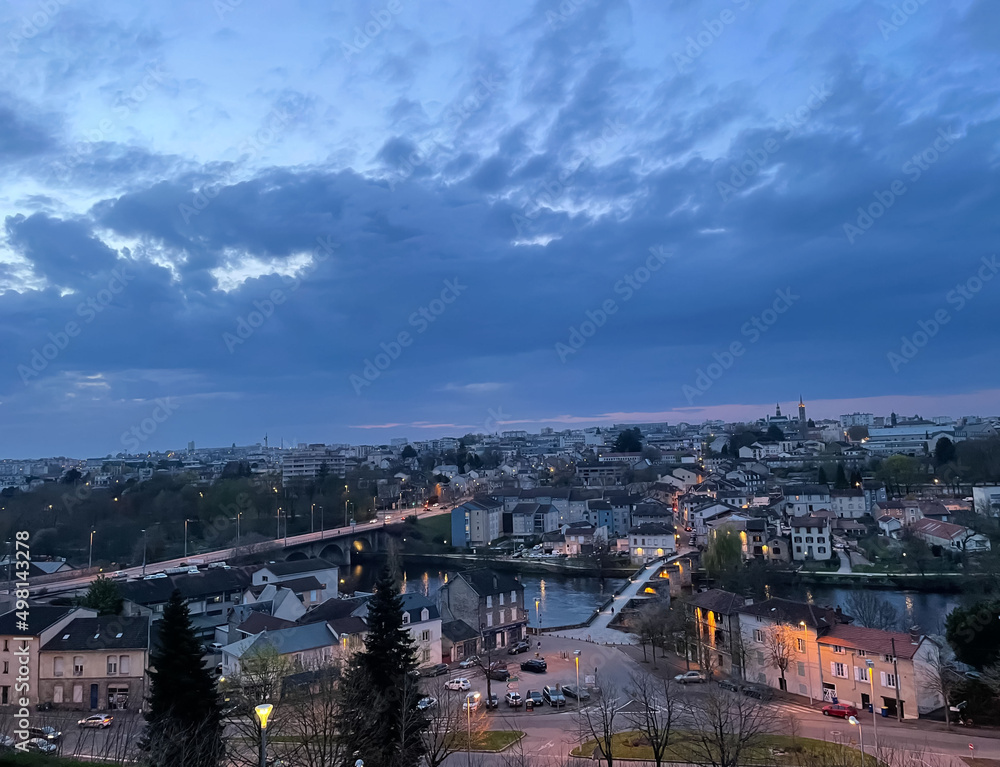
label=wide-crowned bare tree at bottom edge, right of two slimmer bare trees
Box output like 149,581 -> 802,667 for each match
687,687 -> 771,767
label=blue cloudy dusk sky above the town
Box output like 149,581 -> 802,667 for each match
0,0 -> 1000,457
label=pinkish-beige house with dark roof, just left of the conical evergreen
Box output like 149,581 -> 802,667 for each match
37,615 -> 152,711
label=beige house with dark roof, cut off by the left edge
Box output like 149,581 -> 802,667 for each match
0,602 -> 97,706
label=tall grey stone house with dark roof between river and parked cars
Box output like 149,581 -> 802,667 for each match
438,568 -> 528,649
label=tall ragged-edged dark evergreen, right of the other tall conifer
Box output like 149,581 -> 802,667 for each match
340,568 -> 427,767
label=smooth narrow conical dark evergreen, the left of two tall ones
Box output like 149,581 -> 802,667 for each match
142,591 -> 224,767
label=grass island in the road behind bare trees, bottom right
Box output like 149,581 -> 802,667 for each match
571,730 -> 884,767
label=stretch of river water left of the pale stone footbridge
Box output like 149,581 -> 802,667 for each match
347,562 -> 625,628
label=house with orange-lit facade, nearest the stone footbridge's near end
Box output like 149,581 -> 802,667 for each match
687,589 -> 752,677
